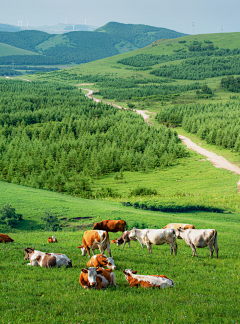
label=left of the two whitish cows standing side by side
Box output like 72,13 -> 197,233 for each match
129,227 -> 177,255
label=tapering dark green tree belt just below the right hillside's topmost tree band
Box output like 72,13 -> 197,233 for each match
150,56 -> 240,80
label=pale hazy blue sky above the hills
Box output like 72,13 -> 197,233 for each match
0,0 -> 240,34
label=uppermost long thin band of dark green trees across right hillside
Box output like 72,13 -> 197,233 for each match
117,48 -> 240,67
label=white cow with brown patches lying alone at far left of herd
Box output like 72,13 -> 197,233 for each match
24,248 -> 72,268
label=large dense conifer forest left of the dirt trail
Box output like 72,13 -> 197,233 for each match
0,80 -> 185,197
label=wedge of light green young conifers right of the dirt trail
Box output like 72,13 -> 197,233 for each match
156,102 -> 240,153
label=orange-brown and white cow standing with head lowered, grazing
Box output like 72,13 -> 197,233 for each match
78,230 -> 111,259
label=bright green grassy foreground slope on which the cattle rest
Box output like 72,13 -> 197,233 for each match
0,182 -> 240,323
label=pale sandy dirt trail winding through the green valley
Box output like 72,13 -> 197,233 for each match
83,89 -> 240,193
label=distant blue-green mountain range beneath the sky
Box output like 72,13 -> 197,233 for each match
0,22 -> 186,65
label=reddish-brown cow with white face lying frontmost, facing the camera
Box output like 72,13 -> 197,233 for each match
79,267 -> 116,289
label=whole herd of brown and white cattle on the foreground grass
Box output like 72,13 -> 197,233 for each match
0,220 -> 218,289
